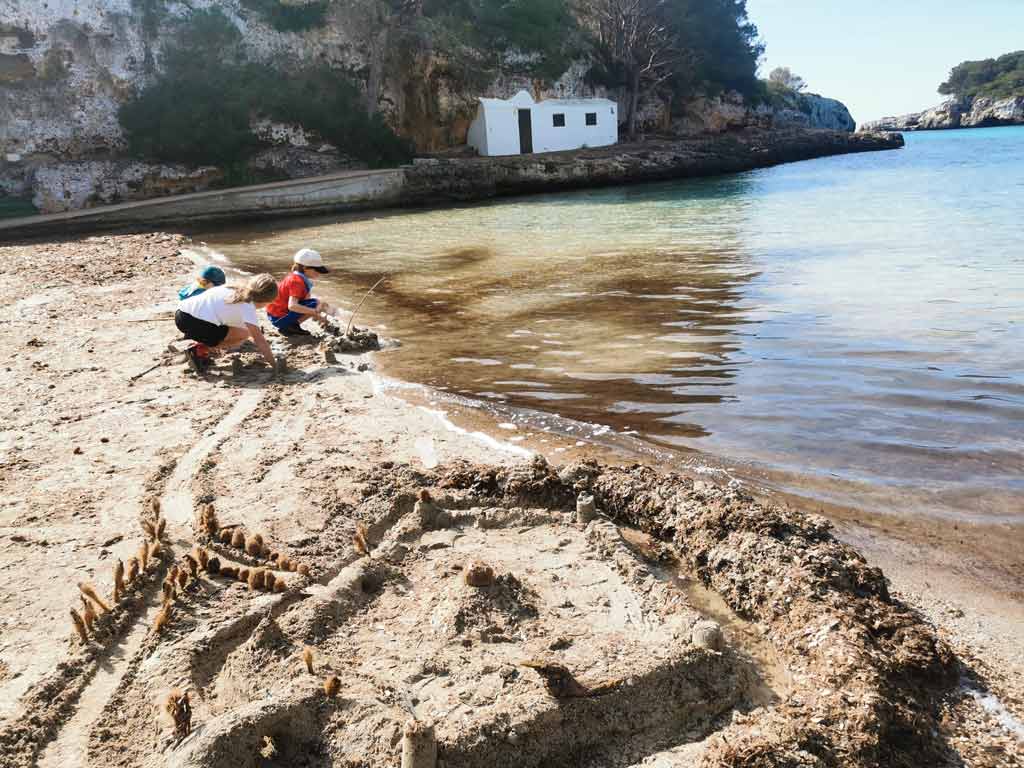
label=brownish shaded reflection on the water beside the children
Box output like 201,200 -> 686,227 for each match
217,179 -> 758,438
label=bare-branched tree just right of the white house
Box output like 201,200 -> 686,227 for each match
593,0 -> 683,139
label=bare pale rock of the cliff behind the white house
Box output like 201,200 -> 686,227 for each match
0,0 -> 854,217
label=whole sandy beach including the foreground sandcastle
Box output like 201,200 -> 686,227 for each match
0,233 -> 1024,766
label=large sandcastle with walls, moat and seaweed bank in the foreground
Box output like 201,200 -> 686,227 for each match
0,461 -> 956,768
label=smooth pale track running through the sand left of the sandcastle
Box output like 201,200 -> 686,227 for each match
38,389 -> 265,768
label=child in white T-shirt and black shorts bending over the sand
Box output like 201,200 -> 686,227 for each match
174,274 -> 278,373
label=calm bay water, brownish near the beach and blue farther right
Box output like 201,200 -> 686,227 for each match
202,128 -> 1024,521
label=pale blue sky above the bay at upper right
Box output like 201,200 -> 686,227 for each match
746,0 -> 1024,123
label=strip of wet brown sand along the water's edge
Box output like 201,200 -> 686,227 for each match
376,366 -> 1024,655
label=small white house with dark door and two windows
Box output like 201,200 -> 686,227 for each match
469,91 -> 618,156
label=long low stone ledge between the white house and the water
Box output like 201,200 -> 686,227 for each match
0,129 -> 904,242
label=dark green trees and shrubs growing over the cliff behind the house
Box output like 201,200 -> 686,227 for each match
119,0 -> 763,167
